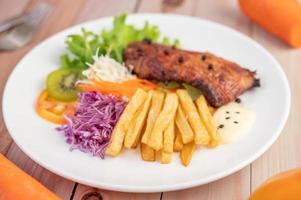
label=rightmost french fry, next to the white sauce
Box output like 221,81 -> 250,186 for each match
195,95 -> 220,147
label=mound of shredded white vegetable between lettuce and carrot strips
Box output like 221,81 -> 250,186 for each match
83,52 -> 137,82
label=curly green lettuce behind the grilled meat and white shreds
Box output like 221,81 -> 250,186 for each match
60,14 -> 179,68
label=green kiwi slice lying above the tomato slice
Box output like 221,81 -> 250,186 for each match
46,69 -> 82,101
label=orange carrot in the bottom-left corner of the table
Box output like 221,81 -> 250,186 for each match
0,154 -> 60,200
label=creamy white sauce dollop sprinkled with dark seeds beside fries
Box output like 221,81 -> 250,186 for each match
213,102 -> 256,144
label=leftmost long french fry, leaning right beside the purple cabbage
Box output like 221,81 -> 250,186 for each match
106,89 -> 147,156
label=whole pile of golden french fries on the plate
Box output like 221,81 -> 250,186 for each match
106,89 -> 219,166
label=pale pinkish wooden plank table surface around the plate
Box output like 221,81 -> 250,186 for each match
0,0 -> 301,200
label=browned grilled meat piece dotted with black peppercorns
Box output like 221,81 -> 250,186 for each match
124,41 -> 259,107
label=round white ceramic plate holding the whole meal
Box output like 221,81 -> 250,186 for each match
3,14 -> 290,192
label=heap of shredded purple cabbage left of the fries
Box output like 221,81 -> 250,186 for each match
57,92 -> 127,159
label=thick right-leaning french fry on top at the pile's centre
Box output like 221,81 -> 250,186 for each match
147,93 -> 178,151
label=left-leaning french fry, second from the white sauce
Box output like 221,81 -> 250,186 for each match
177,89 -> 210,145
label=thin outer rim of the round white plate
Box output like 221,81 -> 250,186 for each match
2,13 -> 291,193
